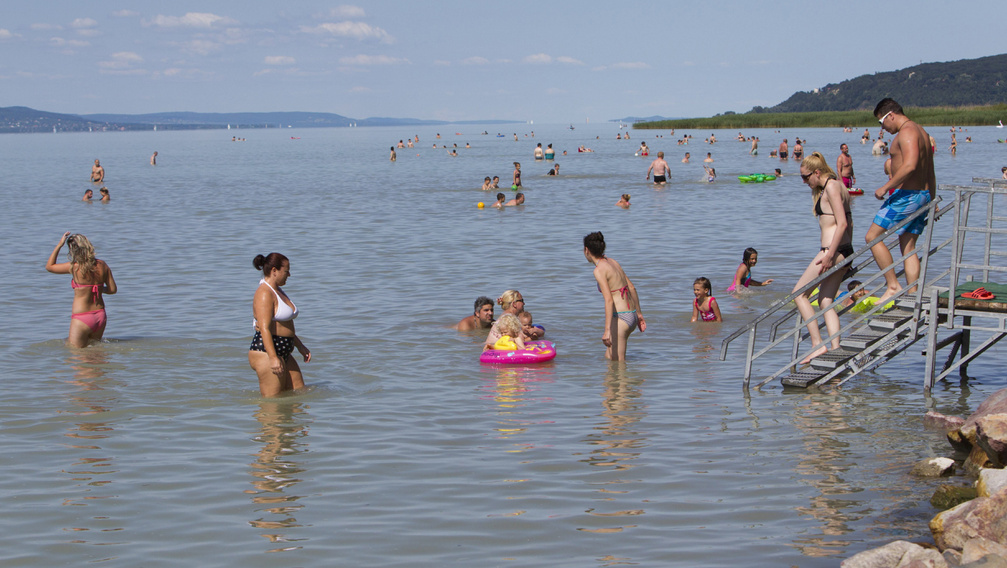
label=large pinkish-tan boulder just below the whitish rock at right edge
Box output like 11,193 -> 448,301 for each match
930,490 -> 1007,550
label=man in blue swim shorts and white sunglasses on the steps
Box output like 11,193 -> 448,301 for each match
866,99 -> 938,303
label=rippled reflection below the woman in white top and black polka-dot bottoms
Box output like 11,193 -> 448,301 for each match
245,400 -> 309,552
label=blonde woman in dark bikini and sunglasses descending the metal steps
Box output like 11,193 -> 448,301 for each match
794,152 -> 853,365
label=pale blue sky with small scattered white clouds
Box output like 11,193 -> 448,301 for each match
0,0 -> 1007,123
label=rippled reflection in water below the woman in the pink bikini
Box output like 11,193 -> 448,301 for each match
59,345 -> 124,545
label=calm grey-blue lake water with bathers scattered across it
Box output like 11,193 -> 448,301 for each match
0,119 -> 1007,567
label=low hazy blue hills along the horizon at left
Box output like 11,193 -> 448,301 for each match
0,107 -> 523,133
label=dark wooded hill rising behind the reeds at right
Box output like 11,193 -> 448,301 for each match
749,54 -> 1007,113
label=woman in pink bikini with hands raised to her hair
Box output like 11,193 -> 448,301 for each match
45,232 -> 117,347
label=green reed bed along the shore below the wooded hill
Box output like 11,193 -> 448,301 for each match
632,105 -> 1007,130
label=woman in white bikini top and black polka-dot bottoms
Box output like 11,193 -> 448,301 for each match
249,253 -> 311,397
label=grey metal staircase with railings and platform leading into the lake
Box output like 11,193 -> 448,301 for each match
720,178 -> 1007,391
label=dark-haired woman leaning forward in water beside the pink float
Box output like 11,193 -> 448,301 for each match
584,232 -> 646,361
